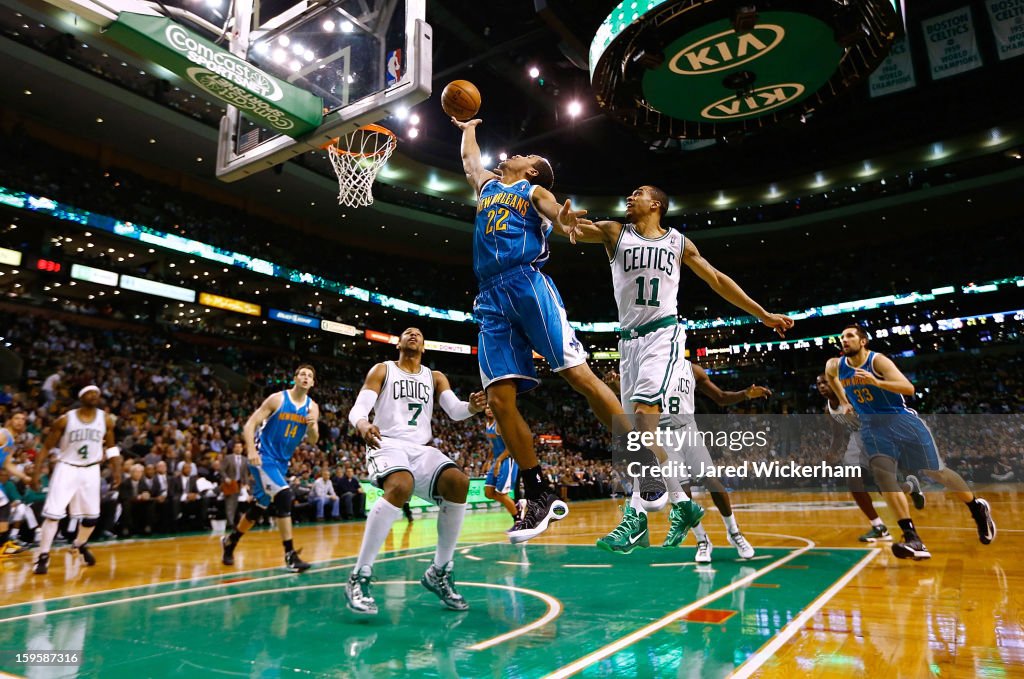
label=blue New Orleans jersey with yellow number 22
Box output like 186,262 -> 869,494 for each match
473,179 -> 551,283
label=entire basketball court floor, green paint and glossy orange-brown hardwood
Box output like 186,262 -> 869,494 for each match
0,491 -> 1024,679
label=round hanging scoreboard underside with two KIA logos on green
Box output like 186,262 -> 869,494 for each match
590,0 -> 901,141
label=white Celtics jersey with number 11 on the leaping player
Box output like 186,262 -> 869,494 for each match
609,224 -> 685,330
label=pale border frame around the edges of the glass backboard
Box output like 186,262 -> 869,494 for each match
217,0 -> 433,181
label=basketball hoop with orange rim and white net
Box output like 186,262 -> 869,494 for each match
323,125 -> 398,208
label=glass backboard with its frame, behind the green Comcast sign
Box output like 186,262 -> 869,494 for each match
217,0 -> 432,181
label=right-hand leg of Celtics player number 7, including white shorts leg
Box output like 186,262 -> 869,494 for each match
413,458 -> 469,610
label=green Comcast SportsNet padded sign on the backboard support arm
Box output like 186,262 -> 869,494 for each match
106,12 -> 324,137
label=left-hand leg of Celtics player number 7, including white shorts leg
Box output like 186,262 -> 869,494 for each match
345,445 -> 413,616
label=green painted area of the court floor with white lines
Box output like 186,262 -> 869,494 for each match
0,541 -> 872,679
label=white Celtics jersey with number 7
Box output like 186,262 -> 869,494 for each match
374,360 -> 434,445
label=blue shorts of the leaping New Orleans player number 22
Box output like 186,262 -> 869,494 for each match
473,266 -> 587,392
